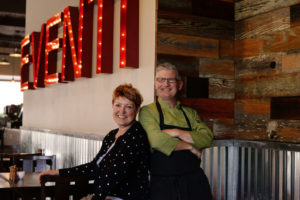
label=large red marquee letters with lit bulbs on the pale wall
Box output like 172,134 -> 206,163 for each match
21,0 -> 139,91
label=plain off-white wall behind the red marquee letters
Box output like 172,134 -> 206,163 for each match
23,0 -> 156,135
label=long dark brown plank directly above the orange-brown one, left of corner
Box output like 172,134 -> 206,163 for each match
157,11 -> 234,40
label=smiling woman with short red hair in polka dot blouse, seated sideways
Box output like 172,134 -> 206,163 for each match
40,84 -> 150,200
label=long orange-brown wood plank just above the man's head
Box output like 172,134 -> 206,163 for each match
157,33 -> 219,58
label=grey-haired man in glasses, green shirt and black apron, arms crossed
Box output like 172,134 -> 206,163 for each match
139,63 -> 213,200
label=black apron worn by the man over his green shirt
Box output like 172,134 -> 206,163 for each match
150,102 -> 212,200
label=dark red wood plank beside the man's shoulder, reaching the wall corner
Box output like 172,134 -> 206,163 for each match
181,98 -> 234,119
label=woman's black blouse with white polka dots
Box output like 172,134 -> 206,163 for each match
59,122 -> 150,200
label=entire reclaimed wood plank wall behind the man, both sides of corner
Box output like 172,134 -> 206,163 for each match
157,0 -> 300,142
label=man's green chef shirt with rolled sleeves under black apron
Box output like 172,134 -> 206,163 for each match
139,99 -> 213,155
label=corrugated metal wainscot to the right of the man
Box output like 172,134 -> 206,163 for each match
202,140 -> 300,200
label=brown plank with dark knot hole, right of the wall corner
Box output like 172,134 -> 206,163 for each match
235,53 -> 284,78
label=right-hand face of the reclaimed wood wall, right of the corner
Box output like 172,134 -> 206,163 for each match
235,0 -> 300,142
